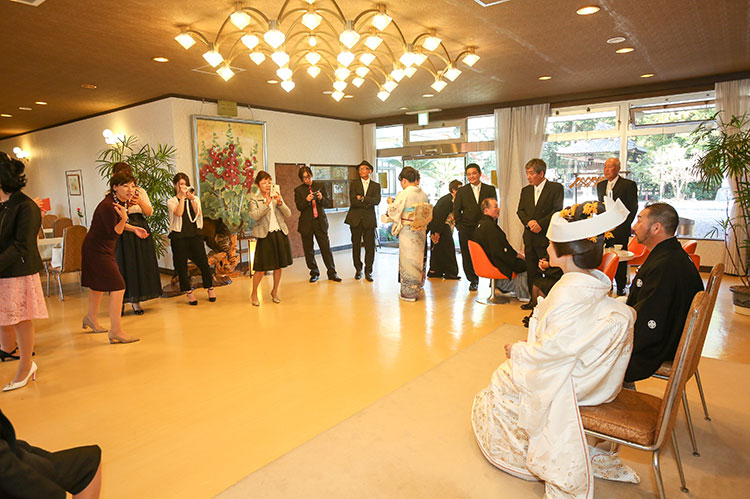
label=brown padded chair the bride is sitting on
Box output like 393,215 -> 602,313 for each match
580,291 -> 709,499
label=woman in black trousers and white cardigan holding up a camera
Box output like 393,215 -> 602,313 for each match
167,173 -> 216,305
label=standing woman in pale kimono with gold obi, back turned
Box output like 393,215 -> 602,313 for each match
381,166 -> 432,301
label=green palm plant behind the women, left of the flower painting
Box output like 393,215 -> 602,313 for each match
96,136 -> 176,257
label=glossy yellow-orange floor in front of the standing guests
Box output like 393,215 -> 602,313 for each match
0,251 -> 750,498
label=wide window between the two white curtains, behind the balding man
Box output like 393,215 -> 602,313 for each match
542,92 -> 729,242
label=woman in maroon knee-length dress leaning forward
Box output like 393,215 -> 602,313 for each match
81,172 -> 142,343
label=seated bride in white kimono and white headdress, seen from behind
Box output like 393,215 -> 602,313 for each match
472,199 -> 637,498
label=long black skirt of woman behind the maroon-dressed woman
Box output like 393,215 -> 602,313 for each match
115,213 -> 161,303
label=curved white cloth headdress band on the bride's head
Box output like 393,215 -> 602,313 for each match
547,196 -> 630,243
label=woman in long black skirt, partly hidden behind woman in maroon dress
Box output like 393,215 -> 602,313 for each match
112,163 -> 161,315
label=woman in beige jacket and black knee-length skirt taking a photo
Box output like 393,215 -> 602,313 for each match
250,171 -> 292,307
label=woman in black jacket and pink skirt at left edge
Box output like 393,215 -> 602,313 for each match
0,152 -> 47,392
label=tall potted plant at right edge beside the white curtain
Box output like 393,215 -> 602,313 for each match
693,115 -> 750,315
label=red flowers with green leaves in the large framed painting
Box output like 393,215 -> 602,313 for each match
198,125 -> 258,233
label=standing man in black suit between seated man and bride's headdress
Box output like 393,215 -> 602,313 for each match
516,158 -> 564,310
